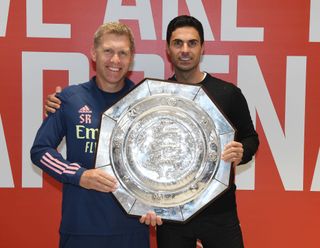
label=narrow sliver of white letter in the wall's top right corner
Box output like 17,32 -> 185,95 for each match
309,0 -> 320,42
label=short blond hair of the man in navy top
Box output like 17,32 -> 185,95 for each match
93,22 -> 135,52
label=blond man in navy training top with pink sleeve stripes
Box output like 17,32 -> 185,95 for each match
31,22 -> 161,248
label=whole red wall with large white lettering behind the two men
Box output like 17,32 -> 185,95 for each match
0,0 -> 320,248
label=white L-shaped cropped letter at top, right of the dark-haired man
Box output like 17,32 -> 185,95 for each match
221,0 -> 264,41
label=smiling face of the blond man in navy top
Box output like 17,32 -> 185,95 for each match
91,33 -> 133,89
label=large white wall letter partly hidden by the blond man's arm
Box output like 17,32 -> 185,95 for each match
22,52 -> 89,187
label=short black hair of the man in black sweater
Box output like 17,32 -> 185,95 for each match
167,15 -> 204,45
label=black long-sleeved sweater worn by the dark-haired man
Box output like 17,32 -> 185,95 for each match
169,73 -> 259,215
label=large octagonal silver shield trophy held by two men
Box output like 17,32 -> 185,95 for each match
95,79 -> 235,222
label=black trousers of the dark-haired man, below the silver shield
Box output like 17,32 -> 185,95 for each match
157,211 -> 244,248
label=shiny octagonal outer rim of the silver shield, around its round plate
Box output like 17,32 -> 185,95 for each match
95,78 -> 235,222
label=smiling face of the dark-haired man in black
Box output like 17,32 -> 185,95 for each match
167,27 -> 203,72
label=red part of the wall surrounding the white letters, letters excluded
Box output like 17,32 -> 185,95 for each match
0,0 -> 320,248
